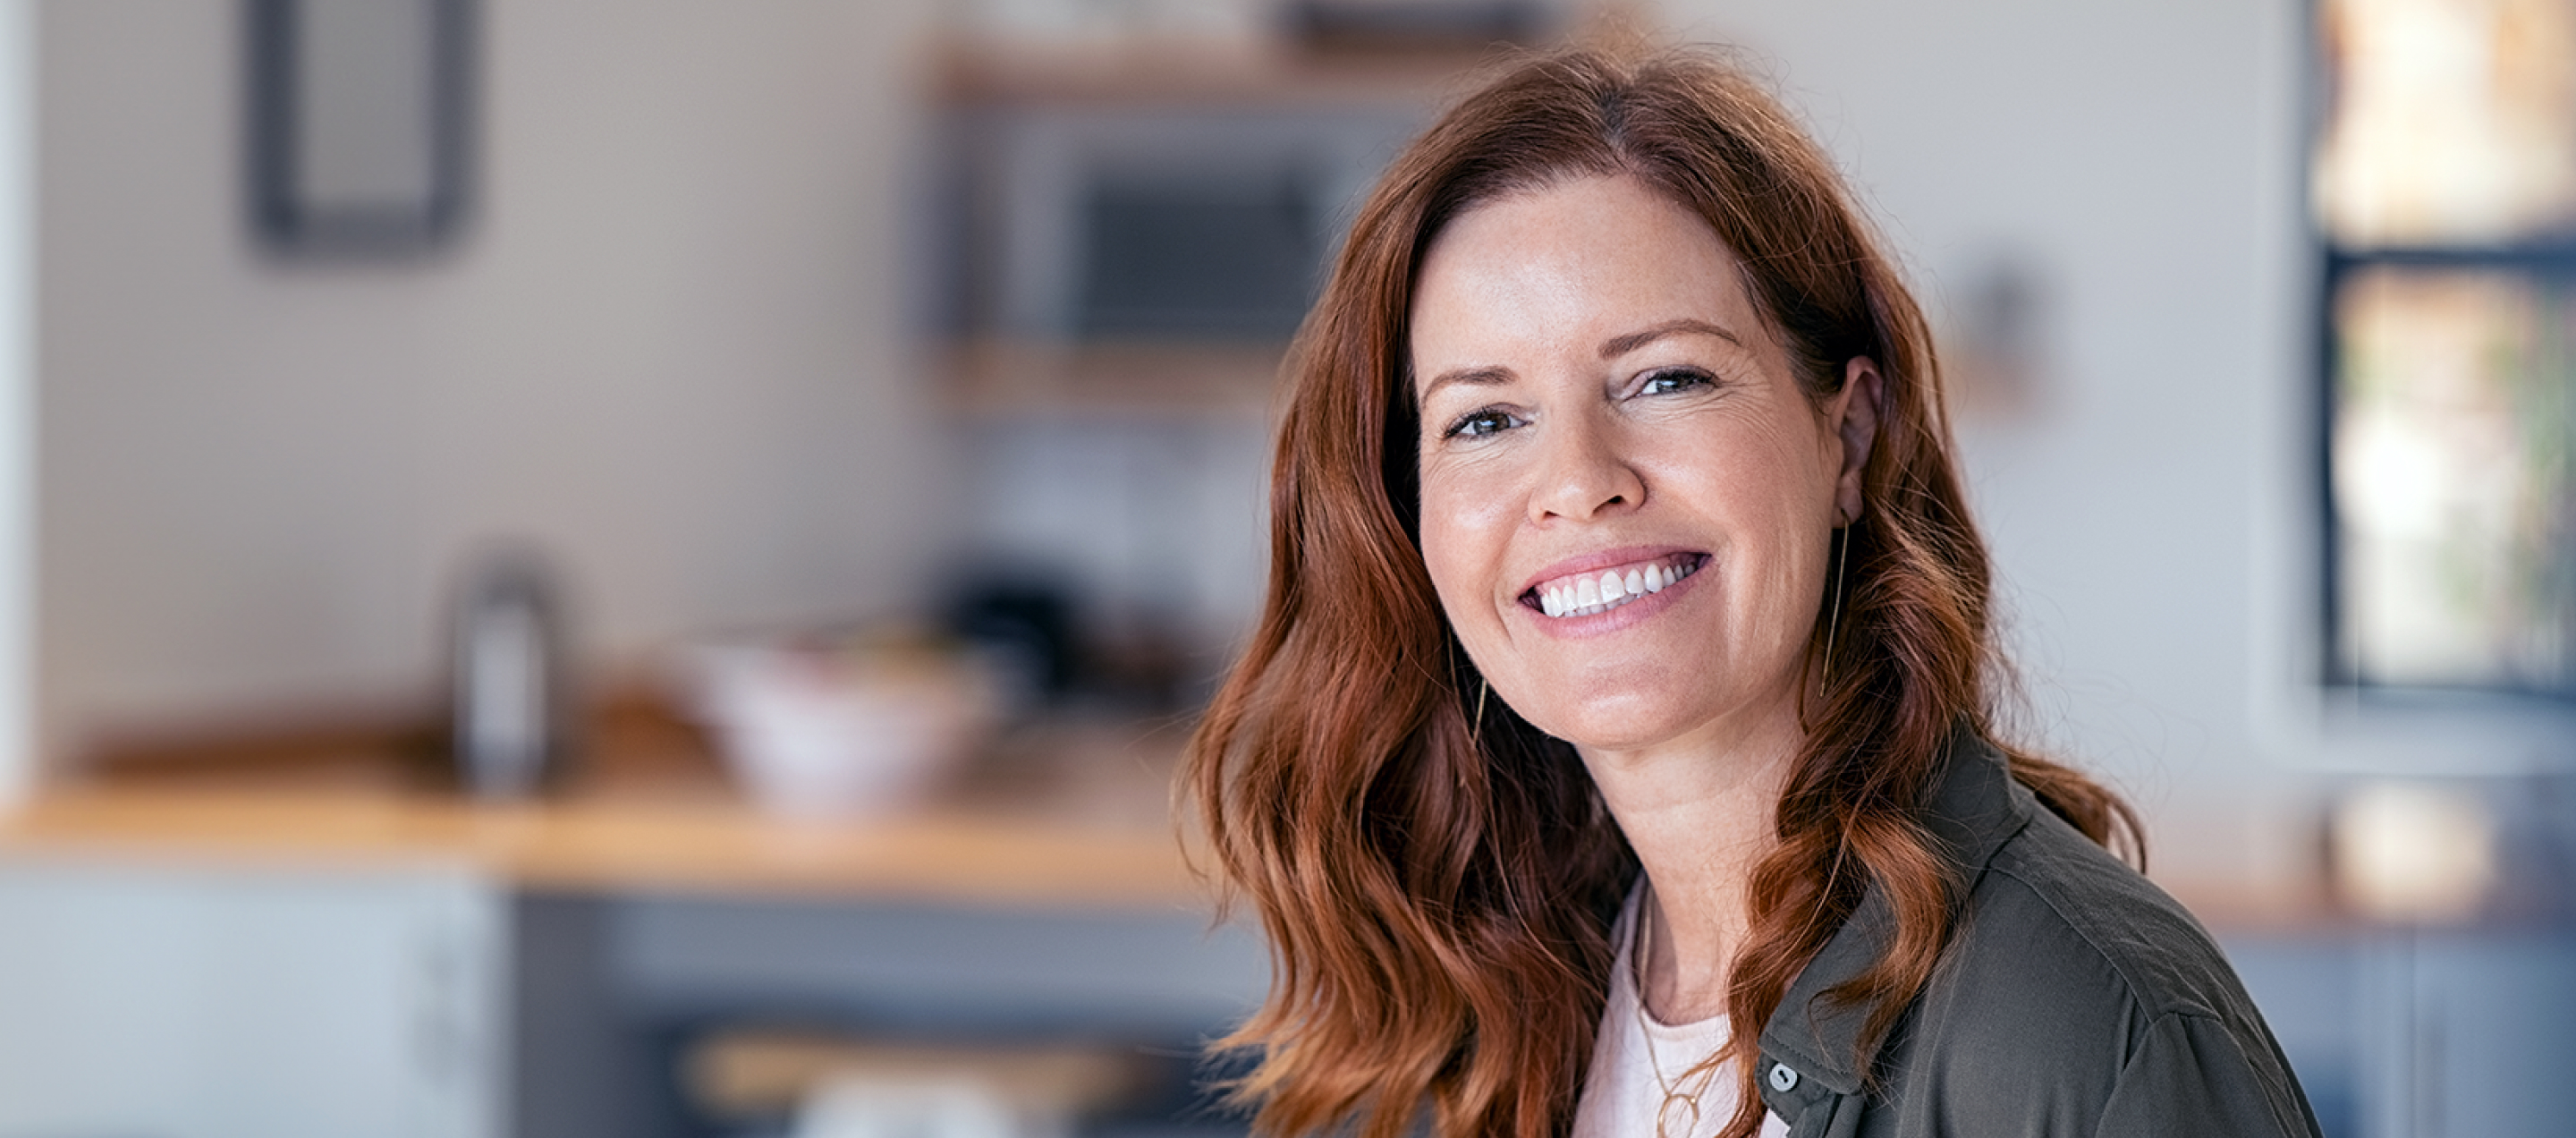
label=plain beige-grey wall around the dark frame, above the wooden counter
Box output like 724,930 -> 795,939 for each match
40,0 -> 945,749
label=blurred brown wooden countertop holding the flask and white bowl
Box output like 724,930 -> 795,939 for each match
0,708 -> 1206,909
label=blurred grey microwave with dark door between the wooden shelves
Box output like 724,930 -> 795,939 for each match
930,100 -> 1429,345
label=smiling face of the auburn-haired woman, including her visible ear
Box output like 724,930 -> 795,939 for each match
1409,178 -> 1878,754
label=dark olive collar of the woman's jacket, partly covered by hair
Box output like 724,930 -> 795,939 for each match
1762,726 -> 2038,1094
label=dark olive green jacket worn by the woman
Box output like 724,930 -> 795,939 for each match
1757,734 -> 2318,1138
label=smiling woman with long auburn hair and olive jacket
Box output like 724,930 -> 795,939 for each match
1182,39 -> 2316,1138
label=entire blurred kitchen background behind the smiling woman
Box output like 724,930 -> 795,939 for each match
0,0 -> 2576,1138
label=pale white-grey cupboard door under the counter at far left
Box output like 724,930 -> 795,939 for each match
0,860 -> 507,1138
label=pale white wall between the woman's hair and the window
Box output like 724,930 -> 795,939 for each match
1664,0 -> 2318,878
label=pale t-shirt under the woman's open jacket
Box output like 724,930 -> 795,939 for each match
1574,888 -> 1788,1138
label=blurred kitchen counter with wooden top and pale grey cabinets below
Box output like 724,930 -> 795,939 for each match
0,728 -> 1267,1138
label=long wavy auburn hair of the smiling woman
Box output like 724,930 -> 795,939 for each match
1180,47 -> 2138,1138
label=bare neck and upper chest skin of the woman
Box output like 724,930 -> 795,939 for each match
1581,710 -> 1803,1022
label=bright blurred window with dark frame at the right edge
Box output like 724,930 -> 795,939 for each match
2310,0 -> 2576,698
